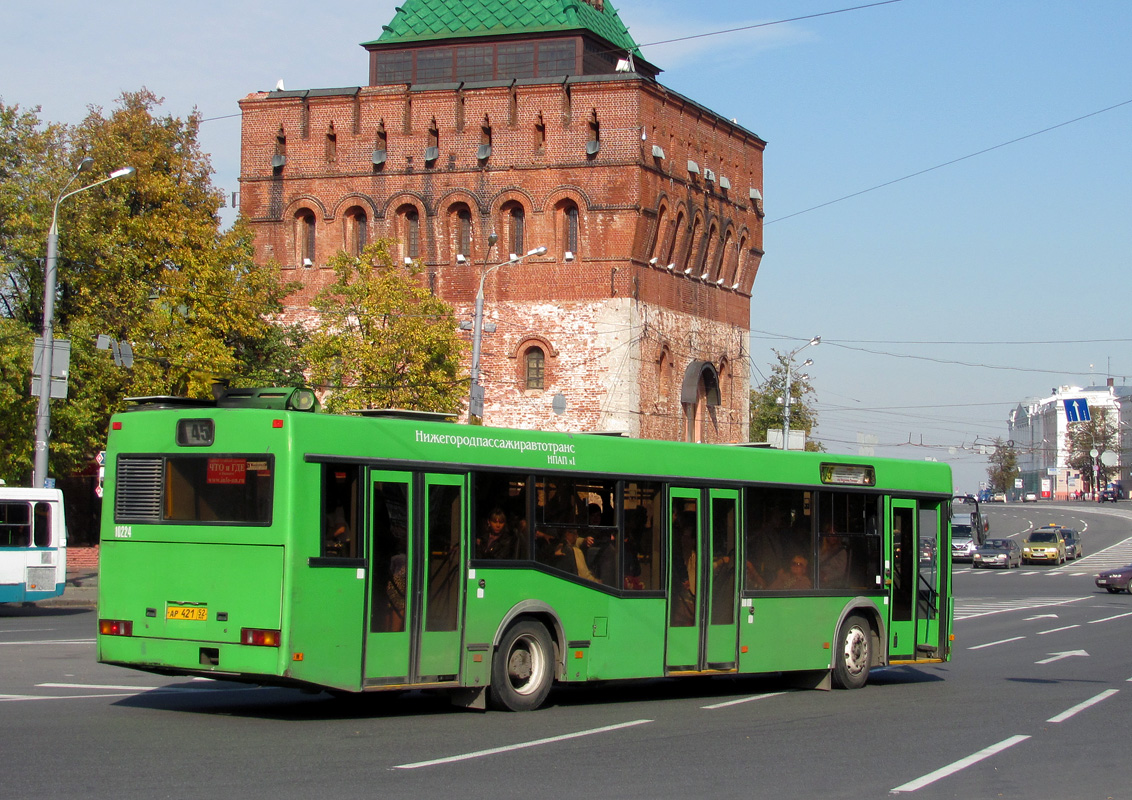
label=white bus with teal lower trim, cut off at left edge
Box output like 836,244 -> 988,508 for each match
0,487 -> 67,603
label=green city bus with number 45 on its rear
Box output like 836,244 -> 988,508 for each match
97,388 -> 952,711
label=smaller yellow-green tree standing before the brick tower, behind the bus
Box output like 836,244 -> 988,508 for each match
305,239 -> 468,412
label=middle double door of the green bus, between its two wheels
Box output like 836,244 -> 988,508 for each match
664,488 -> 739,672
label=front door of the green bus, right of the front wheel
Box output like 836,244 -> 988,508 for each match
889,500 -> 950,659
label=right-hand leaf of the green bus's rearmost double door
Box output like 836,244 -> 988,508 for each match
410,475 -> 468,682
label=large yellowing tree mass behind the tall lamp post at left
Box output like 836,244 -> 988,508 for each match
0,89 -> 303,482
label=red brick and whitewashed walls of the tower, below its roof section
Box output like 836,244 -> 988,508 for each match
241,76 -> 764,441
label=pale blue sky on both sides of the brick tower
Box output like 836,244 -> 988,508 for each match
0,0 -> 1132,490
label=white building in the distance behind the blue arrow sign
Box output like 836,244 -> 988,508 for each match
1007,378 -> 1132,500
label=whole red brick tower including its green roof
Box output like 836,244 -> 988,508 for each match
240,0 -> 765,441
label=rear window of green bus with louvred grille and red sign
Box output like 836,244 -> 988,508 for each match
114,455 -> 275,525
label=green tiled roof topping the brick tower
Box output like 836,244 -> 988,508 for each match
362,0 -> 640,55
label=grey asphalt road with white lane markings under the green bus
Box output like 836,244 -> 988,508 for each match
0,505 -> 1132,800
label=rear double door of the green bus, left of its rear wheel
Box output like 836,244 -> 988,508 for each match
365,472 -> 464,686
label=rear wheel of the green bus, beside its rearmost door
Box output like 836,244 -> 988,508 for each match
488,620 -> 555,711
